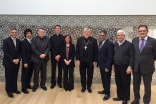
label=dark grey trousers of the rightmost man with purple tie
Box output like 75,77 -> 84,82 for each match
133,68 -> 153,104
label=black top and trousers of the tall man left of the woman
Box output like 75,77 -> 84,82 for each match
50,34 -> 64,85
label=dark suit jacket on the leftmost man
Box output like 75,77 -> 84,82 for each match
3,37 -> 21,67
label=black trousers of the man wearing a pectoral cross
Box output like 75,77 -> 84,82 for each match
80,62 -> 94,89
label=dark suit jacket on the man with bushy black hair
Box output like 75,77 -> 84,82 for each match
21,38 -> 32,64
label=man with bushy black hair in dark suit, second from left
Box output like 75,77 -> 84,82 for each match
21,29 -> 33,94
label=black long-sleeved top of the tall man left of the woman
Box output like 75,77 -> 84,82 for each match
50,34 -> 64,58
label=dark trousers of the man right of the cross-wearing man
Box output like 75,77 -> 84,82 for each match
100,69 -> 111,95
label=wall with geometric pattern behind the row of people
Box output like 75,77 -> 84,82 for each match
0,15 -> 156,84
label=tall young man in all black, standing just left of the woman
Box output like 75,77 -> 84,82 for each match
50,25 -> 64,89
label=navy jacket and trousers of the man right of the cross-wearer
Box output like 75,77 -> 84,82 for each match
98,39 -> 114,95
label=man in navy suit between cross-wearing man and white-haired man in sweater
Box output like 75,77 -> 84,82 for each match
98,30 -> 114,100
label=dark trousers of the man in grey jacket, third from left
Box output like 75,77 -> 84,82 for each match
34,59 -> 47,87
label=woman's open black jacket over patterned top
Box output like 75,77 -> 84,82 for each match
61,44 -> 75,67
